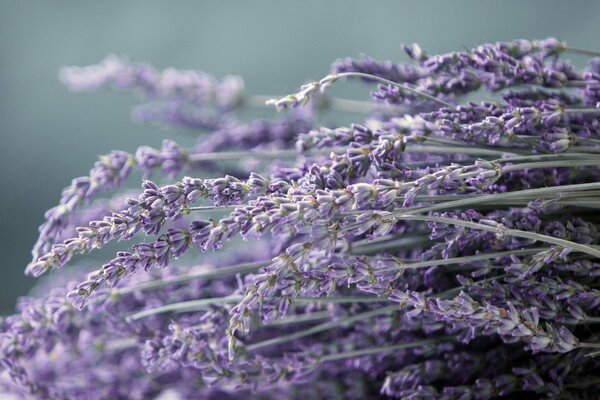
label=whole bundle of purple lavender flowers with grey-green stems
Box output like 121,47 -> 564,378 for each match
0,38 -> 600,400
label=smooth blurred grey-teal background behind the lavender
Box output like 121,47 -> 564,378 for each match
0,0 -> 600,314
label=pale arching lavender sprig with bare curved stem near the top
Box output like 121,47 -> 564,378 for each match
265,72 -> 452,110
